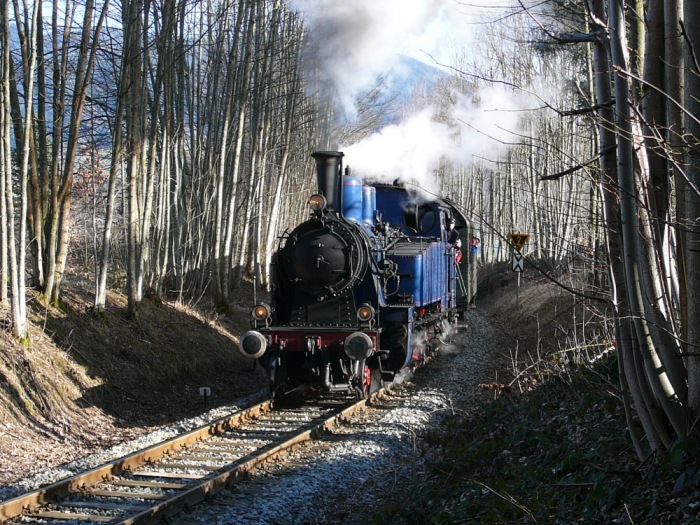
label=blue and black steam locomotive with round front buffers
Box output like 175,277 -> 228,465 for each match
239,151 -> 476,398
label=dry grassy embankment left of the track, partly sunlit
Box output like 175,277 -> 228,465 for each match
0,280 -> 266,484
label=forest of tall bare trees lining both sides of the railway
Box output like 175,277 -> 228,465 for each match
0,0 -> 700,457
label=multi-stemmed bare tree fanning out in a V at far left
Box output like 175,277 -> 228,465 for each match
11,0 -> 109,304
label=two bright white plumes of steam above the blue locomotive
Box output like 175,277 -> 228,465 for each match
290,0 -> 522,194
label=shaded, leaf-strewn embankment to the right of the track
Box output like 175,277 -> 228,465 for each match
374,268 -> 700,525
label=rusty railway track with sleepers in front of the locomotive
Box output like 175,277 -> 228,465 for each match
0,390 -> 383,525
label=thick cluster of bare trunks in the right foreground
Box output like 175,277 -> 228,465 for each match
576,0 -> 693,455
